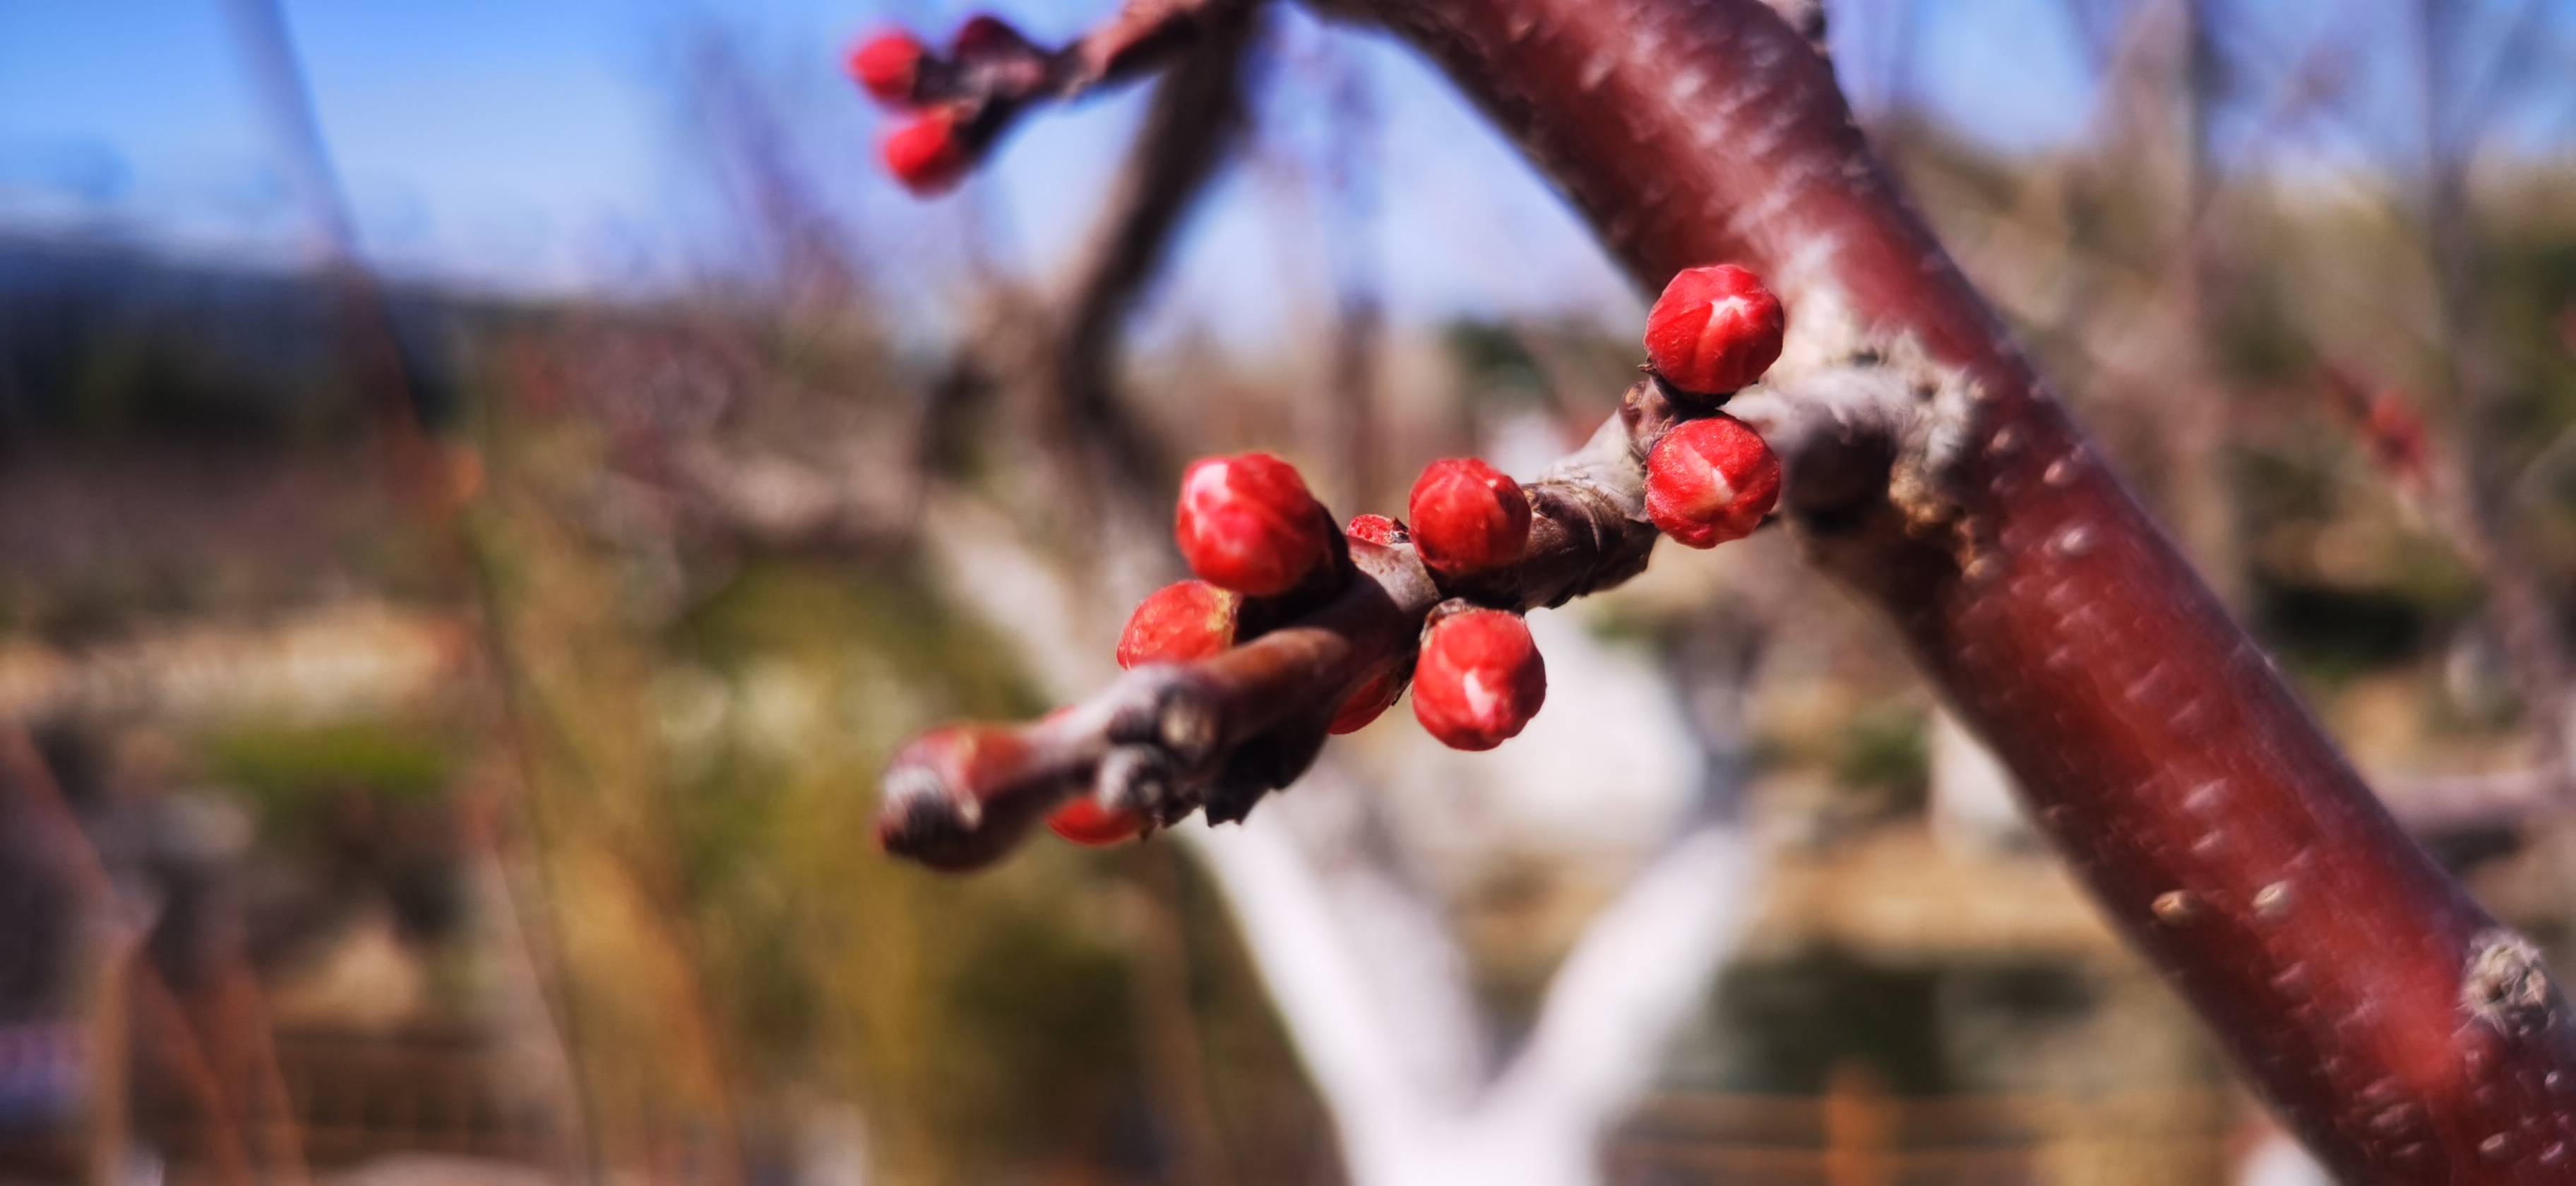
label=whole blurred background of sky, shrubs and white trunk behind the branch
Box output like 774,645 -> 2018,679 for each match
0,0 -> 2576,1186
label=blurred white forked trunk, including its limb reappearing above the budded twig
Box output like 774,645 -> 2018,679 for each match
922,504 -> 1762,1186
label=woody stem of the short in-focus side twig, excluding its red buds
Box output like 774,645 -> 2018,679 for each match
878,378 -> 1803,870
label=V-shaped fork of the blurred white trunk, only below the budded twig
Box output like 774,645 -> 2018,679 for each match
1182,774 -> 1762,1186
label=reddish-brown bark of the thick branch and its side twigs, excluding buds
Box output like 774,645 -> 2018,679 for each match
883,0 -> 2576,1168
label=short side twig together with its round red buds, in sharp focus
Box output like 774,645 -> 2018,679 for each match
886,263 -> 1785,864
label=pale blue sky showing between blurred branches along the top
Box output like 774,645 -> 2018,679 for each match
0,0 -> 2576,337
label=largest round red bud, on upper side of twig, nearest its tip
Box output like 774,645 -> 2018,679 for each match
1172,453 -> 1332,597
